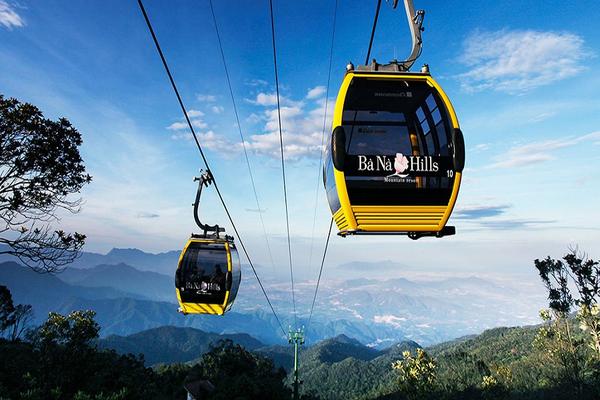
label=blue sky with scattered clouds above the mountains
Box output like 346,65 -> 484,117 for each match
0,0 -> 600,282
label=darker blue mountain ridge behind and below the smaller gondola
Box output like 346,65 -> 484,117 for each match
0,262 -> 281,343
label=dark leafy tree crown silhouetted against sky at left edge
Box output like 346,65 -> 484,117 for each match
0,94 -> 91,272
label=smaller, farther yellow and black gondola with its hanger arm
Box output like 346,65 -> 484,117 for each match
175,171 -> 241,315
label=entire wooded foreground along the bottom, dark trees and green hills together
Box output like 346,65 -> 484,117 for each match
0,313 -> 599,400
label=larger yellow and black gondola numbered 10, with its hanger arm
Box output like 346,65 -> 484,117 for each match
323,0 -> 465,239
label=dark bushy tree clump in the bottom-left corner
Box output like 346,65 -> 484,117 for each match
0,311 -> 173,400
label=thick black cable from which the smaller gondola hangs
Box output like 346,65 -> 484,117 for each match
137,0 -> 287,336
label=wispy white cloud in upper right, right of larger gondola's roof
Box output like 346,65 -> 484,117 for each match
460,30 -> 590,93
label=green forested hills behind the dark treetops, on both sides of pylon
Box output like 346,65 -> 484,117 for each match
92,320 -> 597,399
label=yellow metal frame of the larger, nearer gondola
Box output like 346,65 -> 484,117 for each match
332,72 -> 462,233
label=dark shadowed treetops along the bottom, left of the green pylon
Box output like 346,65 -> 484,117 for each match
0,306 -> 290,400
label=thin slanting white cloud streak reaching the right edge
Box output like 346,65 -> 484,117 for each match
490,131 -> 600,168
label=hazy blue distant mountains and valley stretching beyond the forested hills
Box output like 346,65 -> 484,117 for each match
0,245 -> 545,349
